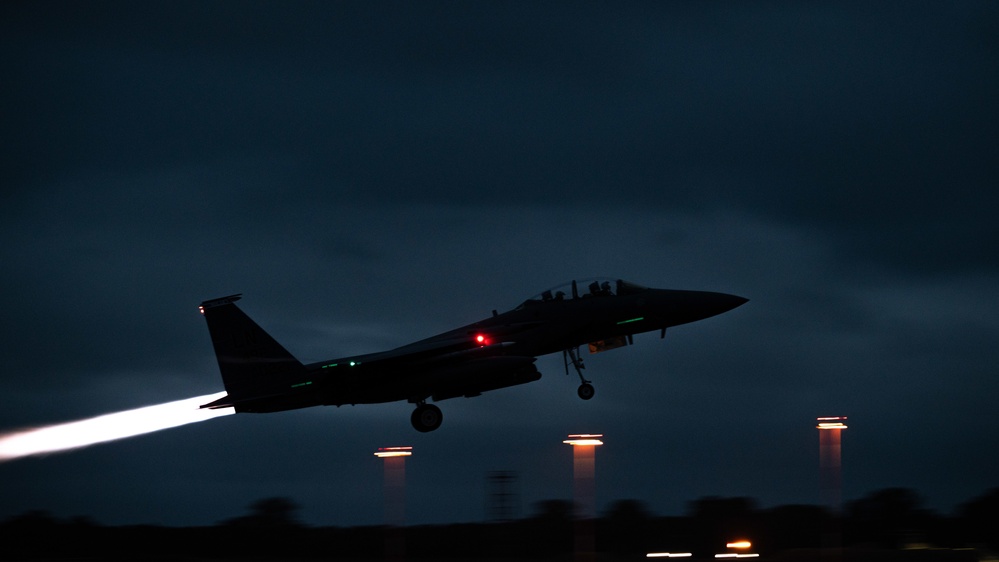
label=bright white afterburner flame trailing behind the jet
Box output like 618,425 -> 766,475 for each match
0,392 -> 235,462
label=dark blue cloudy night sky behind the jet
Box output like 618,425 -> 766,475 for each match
0,0 -> 999,525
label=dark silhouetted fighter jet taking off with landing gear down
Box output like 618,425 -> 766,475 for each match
199,278 -> 747,433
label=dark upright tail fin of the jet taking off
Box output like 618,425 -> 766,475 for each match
199,294 -> 305,400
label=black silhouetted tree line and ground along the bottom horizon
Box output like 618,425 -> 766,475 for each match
0,488 -> 999,561
